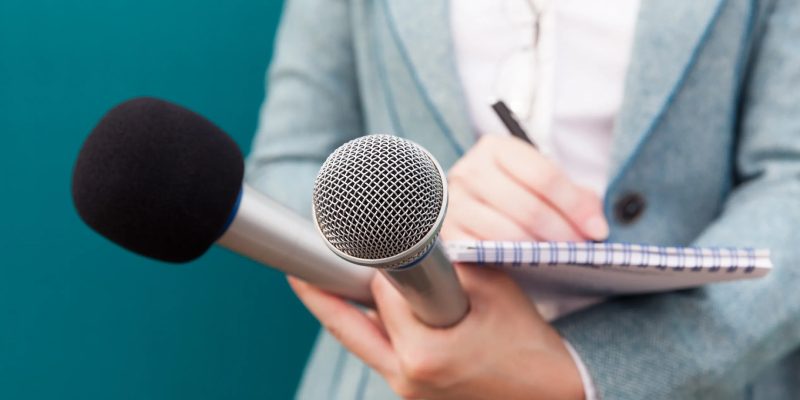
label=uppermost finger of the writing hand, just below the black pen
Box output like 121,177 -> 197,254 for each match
494,138 -> 608,240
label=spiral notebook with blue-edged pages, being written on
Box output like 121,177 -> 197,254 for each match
444,241 -> 772,296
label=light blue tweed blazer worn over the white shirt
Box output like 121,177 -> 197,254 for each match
247,0 -> 800,399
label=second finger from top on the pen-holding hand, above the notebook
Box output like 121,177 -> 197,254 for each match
453,160 -> 584,240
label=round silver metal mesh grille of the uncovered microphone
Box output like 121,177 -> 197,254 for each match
313,135 -> 444,260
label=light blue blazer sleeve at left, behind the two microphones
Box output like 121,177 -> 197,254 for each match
245,0 -> 363,217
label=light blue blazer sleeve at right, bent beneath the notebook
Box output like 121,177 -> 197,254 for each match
556,0 -> 800,399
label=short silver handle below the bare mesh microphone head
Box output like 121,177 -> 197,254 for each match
381,243 -> 469,328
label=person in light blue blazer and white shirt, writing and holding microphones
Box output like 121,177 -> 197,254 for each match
248,0 -> 800,399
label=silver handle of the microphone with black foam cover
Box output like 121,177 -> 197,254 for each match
217,184 -> 374,305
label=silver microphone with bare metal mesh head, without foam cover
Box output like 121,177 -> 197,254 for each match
313,135 -> 469,327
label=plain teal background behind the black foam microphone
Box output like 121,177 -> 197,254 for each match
0,0 -> 317,399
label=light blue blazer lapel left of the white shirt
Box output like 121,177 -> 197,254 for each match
382,0 -> 475,154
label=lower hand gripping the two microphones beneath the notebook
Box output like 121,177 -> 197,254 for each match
289,265 -> 584,399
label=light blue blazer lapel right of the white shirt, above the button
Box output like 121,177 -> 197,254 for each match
611,0 -> 725,178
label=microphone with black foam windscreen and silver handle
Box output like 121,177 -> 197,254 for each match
72,98 -> 371,303
